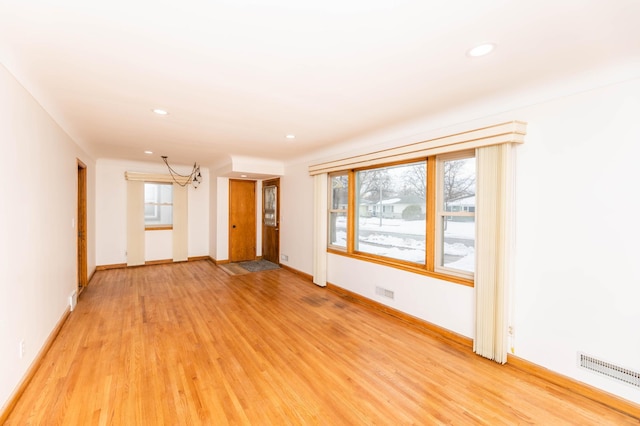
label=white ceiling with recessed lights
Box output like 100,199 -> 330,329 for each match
0,0 -> 640,165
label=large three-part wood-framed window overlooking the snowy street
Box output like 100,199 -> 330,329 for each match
329,151 -> 476,283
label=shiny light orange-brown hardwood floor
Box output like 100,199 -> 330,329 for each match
7,261 -> 639,425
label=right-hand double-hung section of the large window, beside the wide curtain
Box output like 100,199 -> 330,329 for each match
436,153 -> 476,277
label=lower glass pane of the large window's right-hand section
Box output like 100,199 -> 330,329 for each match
440,216 -> 476,272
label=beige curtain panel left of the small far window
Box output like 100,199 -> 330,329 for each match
127,180 -> 144,266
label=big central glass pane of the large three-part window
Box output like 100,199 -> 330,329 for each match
355,161 -> 426,264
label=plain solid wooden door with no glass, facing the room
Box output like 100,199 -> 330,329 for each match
229,179 -> 256,262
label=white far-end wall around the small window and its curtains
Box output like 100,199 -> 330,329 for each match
96,159 -> 209,265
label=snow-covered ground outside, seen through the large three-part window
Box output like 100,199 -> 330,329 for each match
333,217 -> 475,272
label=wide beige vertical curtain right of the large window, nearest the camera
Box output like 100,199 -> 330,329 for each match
473,143 -> 515,364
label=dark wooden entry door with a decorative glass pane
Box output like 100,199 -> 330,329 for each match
262,179 -> 280,264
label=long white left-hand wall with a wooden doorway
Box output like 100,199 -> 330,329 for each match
0,65 -> 96,406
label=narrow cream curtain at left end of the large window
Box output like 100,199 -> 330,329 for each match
313,173 -> 328,287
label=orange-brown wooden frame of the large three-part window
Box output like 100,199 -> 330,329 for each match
327,150 -> 477,287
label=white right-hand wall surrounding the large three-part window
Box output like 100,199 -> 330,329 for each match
281,64 -> 640,403
